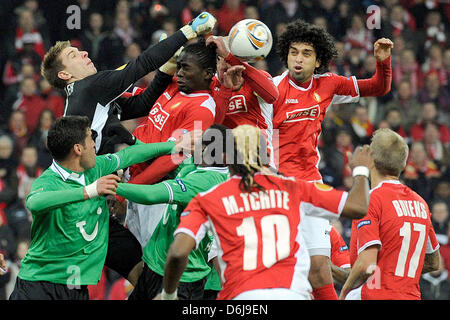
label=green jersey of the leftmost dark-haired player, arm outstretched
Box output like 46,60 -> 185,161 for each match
18,141 -> 175,286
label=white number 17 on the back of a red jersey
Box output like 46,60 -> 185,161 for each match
395,222 -> 426,278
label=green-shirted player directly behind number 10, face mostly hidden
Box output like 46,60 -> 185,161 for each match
117,124 -> 237,300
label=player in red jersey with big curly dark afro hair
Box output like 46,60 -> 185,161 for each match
273,20 -> 393,300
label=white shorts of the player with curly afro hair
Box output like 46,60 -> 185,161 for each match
300,215 -> 331,258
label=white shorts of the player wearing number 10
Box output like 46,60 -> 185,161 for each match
233,288 -> 311,300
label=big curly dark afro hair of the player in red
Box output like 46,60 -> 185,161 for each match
276,19 -> 337,74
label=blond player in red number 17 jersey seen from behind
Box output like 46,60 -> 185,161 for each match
340,129 -> 440,300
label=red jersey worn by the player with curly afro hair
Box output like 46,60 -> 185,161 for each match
273,71 -> 359,181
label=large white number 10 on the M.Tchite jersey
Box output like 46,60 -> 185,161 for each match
236,214 -> 290,270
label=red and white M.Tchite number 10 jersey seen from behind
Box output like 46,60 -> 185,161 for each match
175,174 -> 347,299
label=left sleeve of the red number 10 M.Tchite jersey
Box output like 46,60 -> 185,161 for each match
173,196 -> 208,249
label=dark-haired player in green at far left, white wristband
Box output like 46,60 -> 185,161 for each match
10,116 -> 197,300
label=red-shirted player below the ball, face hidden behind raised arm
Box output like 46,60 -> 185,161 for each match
206,36 -> 278,168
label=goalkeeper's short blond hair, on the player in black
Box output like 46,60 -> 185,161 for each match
41,40 -> 70,89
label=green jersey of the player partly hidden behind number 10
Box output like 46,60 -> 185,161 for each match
117,162 -> 229,282
